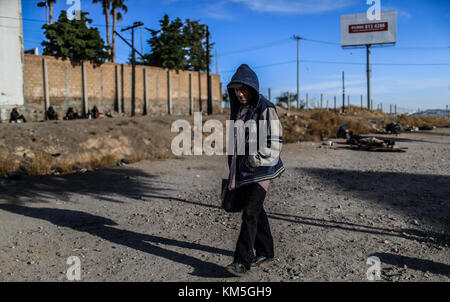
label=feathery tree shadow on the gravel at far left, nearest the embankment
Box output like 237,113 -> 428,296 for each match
0,167 -> 170,204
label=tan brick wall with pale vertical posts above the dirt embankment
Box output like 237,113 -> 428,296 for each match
20,54 -> 222,121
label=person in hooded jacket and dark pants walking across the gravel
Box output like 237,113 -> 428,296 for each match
226,64 -> 285,276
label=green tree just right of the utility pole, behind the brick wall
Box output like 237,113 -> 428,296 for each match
145,14 -> 188,70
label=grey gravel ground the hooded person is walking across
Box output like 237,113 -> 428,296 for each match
0,128 -> 450,282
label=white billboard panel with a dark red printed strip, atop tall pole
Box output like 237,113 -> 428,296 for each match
341,10 -> 397,47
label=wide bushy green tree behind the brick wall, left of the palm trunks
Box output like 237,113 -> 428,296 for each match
42,11 -> 110,66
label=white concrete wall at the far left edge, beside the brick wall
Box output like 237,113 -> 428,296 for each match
0,0 -> 24,119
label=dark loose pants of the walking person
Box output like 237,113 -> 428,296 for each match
234,183 -> 274,269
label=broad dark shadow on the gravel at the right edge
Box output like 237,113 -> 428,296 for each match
297,168 -> 450,232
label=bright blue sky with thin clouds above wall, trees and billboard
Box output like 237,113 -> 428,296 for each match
22,0 -> 450,110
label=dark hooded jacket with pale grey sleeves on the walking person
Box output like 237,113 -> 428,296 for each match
227,64 -> 285,186
